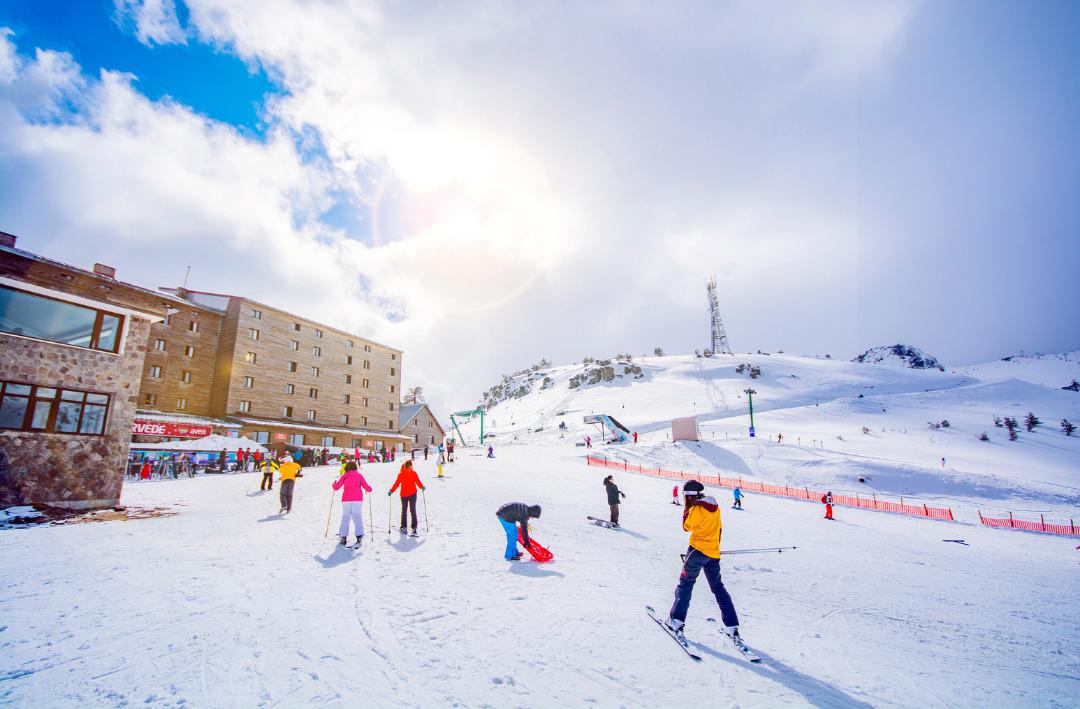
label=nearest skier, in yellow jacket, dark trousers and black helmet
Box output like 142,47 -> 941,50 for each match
666,480 -> 742,645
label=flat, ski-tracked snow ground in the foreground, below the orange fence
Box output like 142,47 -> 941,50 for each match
0,451 -> 1080,709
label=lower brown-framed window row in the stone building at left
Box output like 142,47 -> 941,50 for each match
0,382 -> 109,436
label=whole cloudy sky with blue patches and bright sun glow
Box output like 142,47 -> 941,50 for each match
0,0 -> 1080,416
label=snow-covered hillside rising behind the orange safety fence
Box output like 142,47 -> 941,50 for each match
462,353 -> 1080,520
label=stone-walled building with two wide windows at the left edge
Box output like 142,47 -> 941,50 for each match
0,232 -> 173,509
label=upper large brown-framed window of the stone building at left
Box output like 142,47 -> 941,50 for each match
0,286 -> 124,352
